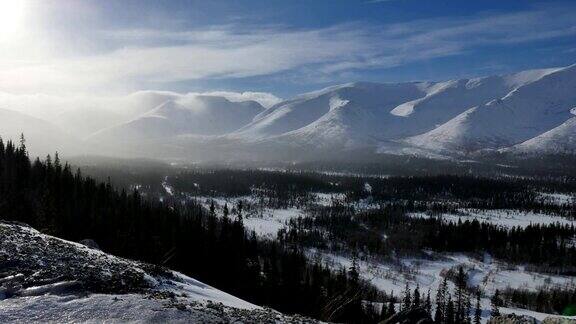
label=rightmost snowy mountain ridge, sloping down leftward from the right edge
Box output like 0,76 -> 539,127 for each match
407,65 -> 576,151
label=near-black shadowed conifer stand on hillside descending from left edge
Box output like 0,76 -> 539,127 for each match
0,140 -> 378,322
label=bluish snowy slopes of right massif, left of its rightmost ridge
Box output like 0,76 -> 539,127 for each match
229,69 -> 569,151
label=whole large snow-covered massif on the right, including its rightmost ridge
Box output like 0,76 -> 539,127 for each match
229,68 -> 574,156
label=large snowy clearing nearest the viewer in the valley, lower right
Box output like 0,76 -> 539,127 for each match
307,249 -> 576,323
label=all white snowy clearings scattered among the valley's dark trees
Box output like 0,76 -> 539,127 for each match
198,193 -> 576,322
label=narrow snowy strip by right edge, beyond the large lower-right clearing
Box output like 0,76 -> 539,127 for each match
408,209 -> 576,228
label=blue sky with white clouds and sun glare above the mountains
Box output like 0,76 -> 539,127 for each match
0,0 -> 576,98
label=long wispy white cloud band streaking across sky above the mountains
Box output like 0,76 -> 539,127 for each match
0,3 -> 576,91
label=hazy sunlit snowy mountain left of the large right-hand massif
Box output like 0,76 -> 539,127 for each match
91,95 -> 264,141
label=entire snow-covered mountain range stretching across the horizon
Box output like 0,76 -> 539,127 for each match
0,65 -> 576,160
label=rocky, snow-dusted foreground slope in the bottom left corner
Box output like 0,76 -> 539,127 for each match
0,221 -> 313,323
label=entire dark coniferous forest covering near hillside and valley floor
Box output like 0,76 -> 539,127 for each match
0,138 -> 576,323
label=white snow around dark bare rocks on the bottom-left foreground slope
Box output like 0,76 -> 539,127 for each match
0,223 -> 288,323
